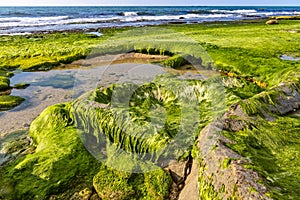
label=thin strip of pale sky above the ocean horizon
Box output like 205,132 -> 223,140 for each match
0,0 -> 300,6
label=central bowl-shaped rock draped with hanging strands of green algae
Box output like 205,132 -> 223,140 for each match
73,75 -> 225,171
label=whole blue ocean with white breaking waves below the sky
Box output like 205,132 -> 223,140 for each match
0,6 -> 300,35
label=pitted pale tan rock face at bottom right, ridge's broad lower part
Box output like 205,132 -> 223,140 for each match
198,120 -> 270,199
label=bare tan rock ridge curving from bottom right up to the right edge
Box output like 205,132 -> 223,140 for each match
184,83 -> 300,199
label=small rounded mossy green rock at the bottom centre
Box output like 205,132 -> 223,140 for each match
93,167 -> 171,200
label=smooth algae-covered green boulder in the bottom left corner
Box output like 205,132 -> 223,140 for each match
0,104 -> 101,199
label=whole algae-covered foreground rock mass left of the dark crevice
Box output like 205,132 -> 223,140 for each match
0,69 -> 223,199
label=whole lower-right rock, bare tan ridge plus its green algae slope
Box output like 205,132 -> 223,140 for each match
197,80 -> 300,199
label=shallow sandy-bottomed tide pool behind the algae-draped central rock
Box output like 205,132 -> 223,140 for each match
0,56 -> 217,137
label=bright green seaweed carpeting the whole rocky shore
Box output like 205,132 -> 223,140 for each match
0,20 -> 300,199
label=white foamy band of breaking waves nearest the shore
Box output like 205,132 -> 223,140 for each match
0,9 -> 300,34
